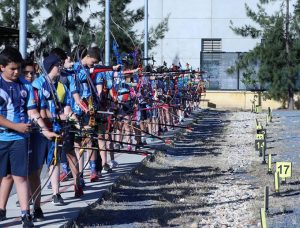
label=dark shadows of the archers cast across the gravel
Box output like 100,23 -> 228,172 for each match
76,111 -> 230,227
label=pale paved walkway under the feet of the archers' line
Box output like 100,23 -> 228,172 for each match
0,116 -> 192,228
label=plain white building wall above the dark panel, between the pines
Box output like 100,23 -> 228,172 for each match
132,0 -> 284,69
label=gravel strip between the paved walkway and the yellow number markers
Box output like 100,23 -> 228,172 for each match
76,110 -> 300,227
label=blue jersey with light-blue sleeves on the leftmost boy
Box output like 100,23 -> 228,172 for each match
0,75 -> 36,141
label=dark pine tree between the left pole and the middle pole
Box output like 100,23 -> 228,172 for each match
40,0 -> 94,51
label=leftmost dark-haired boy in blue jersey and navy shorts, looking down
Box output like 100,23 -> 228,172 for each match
0,47 -> 58,227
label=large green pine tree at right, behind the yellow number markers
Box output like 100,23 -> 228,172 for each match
231,0 -> 300,109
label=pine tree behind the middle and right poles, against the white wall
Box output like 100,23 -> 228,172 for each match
93,0 -> 169,65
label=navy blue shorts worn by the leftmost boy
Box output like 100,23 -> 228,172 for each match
0,139 -> 29,177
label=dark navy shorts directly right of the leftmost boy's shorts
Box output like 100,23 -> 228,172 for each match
29,132 -> 50,173
